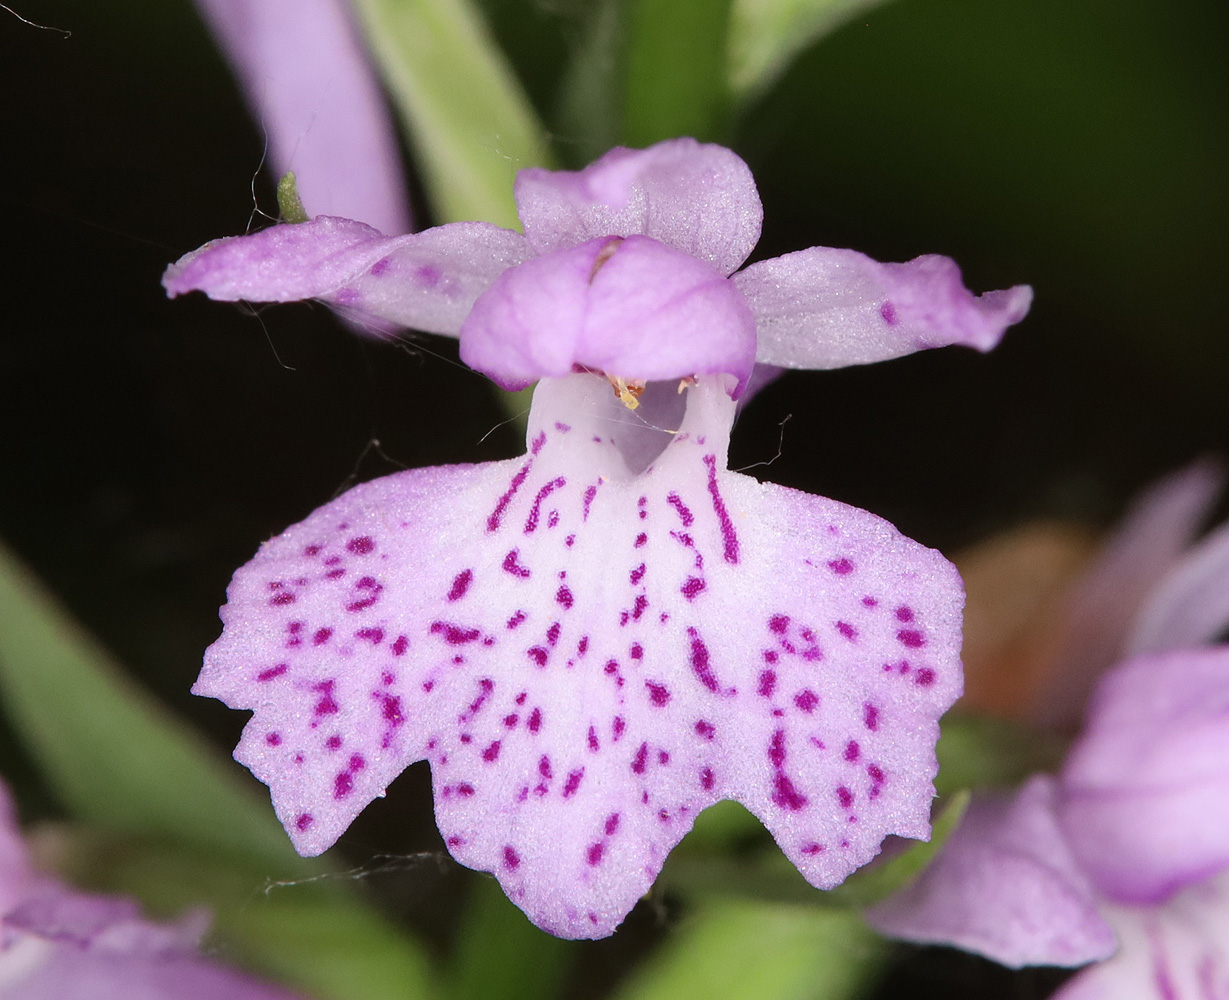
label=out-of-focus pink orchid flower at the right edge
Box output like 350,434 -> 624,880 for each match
868,467 -> 1229,1000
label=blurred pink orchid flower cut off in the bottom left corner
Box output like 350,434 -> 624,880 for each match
0,783 -> 304,1000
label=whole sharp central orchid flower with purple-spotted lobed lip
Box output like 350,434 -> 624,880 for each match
163,139 -> 1030,937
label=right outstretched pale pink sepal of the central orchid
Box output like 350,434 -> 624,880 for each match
734,247 -> 1032,369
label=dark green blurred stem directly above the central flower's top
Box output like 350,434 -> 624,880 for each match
623,0 -> 730,146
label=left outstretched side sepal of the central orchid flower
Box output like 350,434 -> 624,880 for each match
162,216 -> 530,337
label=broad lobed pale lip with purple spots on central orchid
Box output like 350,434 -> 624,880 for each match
194,375 -> 961,937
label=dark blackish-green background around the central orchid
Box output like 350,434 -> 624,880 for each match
0,0 -> 1229,998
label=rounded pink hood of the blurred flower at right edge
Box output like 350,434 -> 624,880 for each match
1059,646 -> 1229,903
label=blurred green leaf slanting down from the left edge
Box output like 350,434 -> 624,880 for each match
0,543 -> 302,873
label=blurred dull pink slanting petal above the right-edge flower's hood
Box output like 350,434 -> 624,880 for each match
1035,462 -> 1224,729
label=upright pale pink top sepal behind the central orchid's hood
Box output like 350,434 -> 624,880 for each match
515,139 -> 763,274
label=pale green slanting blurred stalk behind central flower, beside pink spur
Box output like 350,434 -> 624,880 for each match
354,0 -> 551,229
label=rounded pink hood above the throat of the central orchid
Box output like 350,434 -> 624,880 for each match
461,236 -> 756,396
